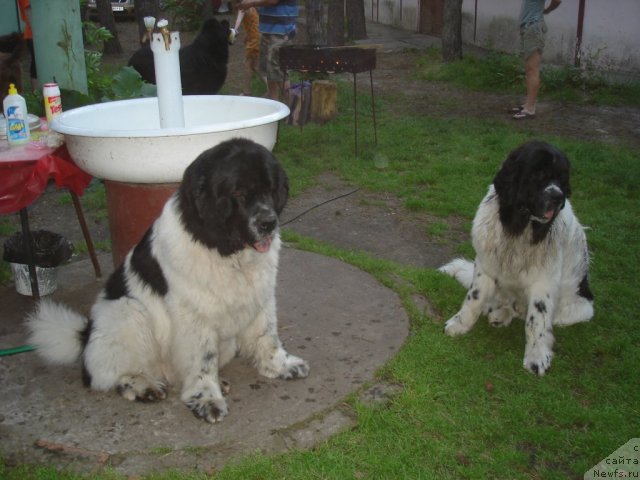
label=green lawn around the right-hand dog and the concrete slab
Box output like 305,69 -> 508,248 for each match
0,60 -> 640,480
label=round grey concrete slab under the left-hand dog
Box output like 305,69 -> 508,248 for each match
0,248 -> 408,475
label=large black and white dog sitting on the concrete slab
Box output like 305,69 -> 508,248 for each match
28,139 -> 309,423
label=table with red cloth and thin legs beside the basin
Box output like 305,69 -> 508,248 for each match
0,140 -> 101,298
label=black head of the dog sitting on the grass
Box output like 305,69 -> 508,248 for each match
493,140 -> 571,243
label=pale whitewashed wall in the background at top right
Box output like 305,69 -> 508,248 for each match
364,0 -> 640,75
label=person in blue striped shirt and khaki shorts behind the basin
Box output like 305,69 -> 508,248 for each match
238,0 -> 298,100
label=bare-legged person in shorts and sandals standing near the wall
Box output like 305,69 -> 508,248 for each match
513,0 -> 562,120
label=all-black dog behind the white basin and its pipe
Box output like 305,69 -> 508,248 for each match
129,18 -> 229,95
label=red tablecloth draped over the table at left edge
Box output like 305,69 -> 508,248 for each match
0,142 -> 92,214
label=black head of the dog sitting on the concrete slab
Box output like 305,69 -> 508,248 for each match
178,139 -> 289,256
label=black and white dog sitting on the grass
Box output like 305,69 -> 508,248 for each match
440,141 -> 593,375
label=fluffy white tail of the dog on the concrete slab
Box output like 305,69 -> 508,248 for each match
27,299 -> 89,365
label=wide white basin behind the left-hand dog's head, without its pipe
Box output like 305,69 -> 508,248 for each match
51,95 -> 289,183
